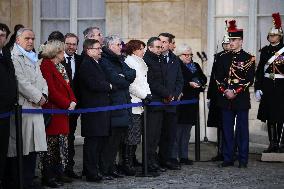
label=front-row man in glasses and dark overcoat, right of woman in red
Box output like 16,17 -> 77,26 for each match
79,39 -> 112,182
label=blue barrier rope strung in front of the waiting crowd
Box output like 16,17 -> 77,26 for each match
0,99 -> 198,118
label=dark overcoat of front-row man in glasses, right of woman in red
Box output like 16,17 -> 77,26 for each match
79,55 -> 111,137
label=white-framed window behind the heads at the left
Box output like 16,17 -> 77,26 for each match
33,0 -> 105,52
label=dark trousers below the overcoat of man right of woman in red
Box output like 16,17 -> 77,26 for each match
83,137 -> 108,177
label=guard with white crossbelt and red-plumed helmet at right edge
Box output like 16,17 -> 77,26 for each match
255,13 -> 284,153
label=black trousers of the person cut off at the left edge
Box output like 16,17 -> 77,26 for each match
0,117 -> 10,182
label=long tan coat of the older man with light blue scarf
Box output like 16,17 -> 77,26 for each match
8,45 -> 48,157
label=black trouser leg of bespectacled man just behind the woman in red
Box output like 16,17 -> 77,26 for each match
65,114 -> 79,171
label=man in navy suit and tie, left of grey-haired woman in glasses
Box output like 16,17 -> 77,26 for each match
156,33 -> 183,170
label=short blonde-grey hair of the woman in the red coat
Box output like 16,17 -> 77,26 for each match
41,40 -> 64,59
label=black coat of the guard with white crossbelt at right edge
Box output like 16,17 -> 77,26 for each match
254,43 -> 284,122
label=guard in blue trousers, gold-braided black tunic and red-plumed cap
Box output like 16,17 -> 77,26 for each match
215,20 -> 255,168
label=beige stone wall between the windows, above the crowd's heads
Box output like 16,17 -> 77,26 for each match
106,0 -> 207,55
